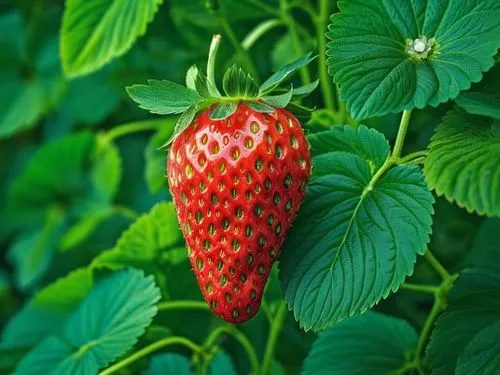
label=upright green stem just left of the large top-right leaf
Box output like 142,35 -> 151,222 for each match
315,0 -> 336,113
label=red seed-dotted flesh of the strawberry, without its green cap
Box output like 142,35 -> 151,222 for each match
167,103 -> 311,323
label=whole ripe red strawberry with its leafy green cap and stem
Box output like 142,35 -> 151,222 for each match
127,35 -> 318,323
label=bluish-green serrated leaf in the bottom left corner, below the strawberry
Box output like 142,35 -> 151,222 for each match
16,269 -> 160,375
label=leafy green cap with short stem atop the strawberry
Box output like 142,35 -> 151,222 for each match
127,35 -> 319,146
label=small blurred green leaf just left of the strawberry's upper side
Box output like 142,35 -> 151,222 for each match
144,118 -> 175,194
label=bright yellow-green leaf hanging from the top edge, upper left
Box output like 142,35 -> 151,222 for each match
61,0 -> 163,77
